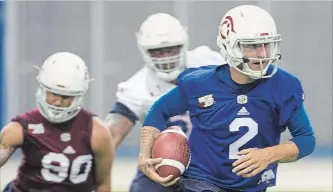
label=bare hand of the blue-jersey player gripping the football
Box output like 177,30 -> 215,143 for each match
139,158 -> 179,187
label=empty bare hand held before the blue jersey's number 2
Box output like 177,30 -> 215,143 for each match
232,148 -> 272,177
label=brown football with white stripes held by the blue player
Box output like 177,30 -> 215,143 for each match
152,126 -> 191,179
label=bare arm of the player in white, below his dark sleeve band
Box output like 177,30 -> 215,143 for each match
105,113 -> 134,148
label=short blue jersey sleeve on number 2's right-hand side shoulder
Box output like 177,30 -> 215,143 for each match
279,77 -> 304,126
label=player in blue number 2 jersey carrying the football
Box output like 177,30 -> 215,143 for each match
139,5 -> 315,192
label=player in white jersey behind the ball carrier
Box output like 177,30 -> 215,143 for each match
105,13 -> 225,192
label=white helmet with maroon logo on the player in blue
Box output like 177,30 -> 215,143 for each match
217,5 -> 282,79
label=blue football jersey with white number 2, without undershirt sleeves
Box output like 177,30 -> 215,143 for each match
178,65 -> 304,191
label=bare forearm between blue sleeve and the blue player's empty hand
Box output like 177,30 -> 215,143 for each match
266,141 -> 299,163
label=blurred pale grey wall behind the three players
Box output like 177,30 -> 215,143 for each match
1,1 -> 332,191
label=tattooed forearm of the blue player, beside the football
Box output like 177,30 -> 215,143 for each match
139,126 -> 160,159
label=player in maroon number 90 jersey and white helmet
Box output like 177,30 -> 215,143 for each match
0,52 -> 115,192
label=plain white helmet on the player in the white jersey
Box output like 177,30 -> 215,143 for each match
136,13 -> 188,81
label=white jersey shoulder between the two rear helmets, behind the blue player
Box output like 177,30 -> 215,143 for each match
187,45 -> 226,68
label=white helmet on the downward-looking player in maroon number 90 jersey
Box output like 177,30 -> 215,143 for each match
35,52 -> 91,123
